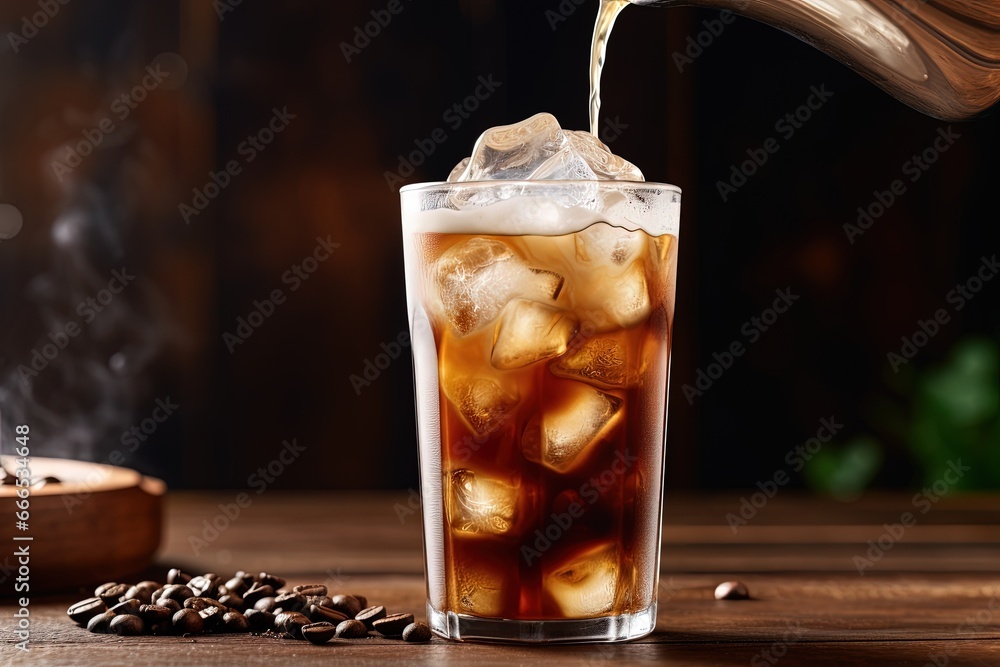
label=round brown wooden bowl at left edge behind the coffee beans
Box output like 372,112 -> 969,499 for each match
0,456 -> 166,597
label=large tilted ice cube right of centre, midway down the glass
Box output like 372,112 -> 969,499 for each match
521,381 -> 623,472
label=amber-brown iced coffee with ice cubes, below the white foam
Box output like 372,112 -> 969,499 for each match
417,230 -> 677,620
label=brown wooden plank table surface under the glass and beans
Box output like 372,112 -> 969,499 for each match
0,491 -> 1000,667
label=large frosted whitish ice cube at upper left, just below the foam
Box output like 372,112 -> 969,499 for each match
434,238 -> 564,336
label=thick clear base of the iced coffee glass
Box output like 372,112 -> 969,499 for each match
427,602 -> 656,644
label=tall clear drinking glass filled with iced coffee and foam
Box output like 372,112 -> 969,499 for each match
400,181 -> 680,642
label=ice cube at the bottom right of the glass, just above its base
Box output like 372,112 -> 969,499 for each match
542,542 -> 621,618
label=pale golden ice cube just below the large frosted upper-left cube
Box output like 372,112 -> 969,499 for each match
491,299 -> 577,370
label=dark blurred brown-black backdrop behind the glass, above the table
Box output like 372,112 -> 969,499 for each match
0,0 -> 1000,497
